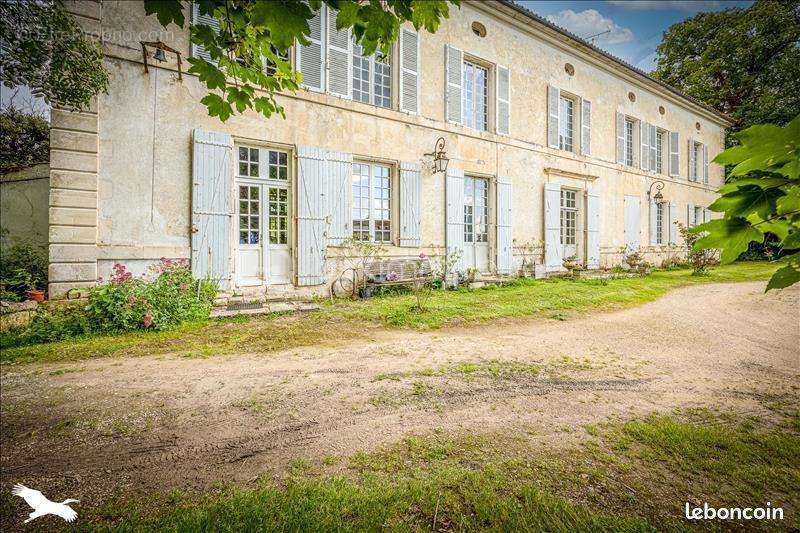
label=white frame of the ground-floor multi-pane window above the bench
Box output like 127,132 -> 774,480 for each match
350,160 -> 396,244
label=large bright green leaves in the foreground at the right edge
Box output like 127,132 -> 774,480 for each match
691,115 -> 800,290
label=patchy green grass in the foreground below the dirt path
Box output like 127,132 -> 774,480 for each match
45,410 -> 800,531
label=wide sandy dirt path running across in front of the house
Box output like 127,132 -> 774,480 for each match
0,283 -> 800,512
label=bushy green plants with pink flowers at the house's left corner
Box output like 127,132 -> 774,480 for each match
4,258 -> 217,345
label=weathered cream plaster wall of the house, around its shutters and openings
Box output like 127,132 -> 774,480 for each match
51,0 -> 723,290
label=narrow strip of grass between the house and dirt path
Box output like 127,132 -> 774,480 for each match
0,262 -> 780,363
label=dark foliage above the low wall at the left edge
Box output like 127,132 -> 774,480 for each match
0,107 -> 50,174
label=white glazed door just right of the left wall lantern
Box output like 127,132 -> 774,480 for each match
463,176 -> 489,272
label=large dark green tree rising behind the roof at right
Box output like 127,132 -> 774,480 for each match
653,0 -> 800,139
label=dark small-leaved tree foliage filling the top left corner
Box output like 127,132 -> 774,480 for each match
0,0 -> 108,109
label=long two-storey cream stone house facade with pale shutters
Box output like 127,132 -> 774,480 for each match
49,0 -> 728,297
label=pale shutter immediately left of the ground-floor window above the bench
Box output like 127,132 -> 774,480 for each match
325,151 -> 353,246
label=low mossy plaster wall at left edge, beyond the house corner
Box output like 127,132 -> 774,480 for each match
0,164 -> 50,246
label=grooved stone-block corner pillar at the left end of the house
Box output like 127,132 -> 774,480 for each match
48,1 -> 101,298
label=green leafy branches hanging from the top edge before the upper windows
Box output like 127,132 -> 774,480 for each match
144,0 -> 459,121
